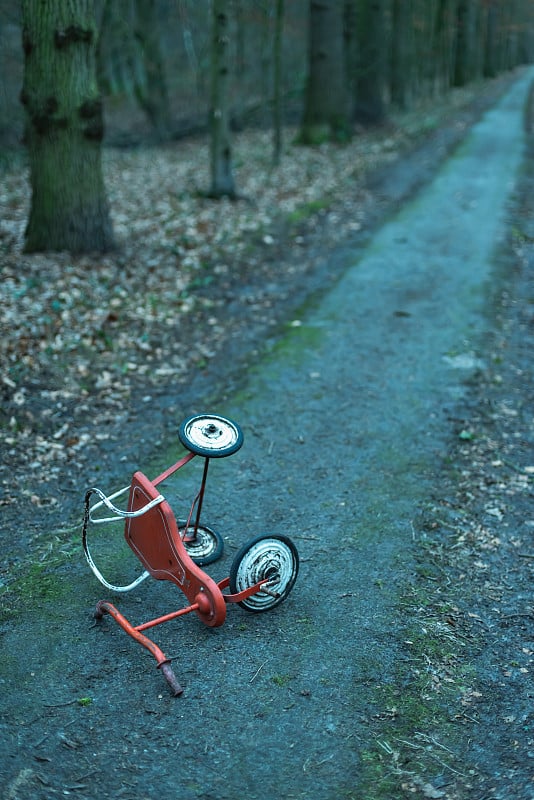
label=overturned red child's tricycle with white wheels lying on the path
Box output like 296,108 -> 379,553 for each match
82,414 -> 299,696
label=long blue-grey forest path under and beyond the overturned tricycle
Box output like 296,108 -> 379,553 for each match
0,72 -> 532,800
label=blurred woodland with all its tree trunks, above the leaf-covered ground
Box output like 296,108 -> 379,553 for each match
0,0 -> 534,252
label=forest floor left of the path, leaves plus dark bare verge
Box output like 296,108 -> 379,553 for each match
0,76 -> 528,528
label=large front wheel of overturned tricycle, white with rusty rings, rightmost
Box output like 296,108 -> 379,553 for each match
230,535 -> 299,612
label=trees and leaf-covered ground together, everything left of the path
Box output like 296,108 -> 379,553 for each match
0,0 -> 534,482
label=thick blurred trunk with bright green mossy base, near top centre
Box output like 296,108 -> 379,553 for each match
300,0 -> 350,145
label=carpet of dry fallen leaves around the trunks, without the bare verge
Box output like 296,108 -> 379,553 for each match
0,117 -> 422,488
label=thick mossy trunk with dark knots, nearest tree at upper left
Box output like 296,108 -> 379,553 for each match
21,0 -> 113,253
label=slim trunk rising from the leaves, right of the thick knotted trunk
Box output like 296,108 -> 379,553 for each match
209,0 -> 236,198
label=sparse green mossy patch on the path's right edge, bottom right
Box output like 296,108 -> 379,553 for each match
358,581 -> 476,800
